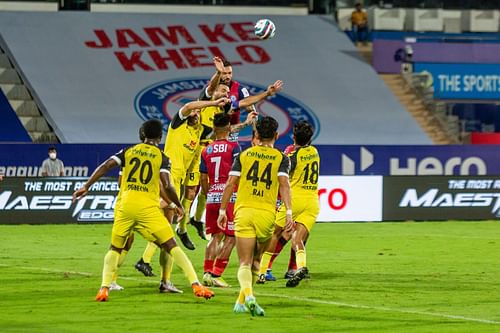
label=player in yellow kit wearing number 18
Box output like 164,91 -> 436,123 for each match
257,121 -> 320,287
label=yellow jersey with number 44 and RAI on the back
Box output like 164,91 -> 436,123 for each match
229,146 -> 290,212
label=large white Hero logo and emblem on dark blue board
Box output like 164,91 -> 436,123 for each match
341,147 -> 488,176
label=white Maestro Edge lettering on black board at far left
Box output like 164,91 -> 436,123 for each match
0,191 -> 115,222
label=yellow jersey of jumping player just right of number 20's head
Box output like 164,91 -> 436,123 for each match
164,111 -> 203,170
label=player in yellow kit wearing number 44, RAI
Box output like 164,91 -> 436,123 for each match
217,116 -> 294,316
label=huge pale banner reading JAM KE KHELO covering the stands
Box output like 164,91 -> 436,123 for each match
0,12 -> 431,144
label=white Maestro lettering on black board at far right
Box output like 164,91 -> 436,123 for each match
399,188 -> 500,217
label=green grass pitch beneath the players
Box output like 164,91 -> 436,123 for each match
0,222 -> 500,333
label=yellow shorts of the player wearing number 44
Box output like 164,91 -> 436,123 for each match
234,208 -> 276,243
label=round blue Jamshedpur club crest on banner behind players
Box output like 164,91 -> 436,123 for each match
134,77 -> 320,145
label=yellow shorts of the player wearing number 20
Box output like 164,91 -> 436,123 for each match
111,205 -> 174,249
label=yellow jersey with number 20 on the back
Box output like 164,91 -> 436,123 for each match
112,143 -> 170,208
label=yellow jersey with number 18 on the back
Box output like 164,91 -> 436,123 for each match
288,146 -> 320,199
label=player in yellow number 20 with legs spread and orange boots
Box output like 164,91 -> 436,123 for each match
73,119 -> 214,302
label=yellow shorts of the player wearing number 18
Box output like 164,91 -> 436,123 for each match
276,197 -> 319,232
